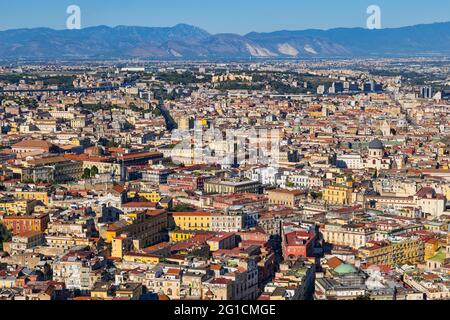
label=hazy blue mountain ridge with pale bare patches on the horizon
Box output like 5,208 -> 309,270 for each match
0,22 -> 450,59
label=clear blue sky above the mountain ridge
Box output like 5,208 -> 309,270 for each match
0,0 -> 450,34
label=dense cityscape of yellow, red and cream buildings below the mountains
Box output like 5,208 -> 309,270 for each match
0,58 -> 450,301
